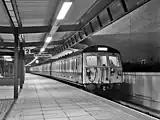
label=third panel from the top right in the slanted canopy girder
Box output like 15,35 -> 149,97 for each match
99,9 -> 111,26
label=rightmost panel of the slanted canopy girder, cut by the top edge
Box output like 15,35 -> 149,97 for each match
124,0 -> 147,10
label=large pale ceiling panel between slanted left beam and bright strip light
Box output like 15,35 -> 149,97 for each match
17,0 -> 58,26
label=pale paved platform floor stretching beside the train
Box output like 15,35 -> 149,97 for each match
6,74 -> 158,120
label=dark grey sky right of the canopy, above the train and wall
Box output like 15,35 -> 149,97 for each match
88,0 -> 160,71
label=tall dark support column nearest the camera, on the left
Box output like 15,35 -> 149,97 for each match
14,28 -> 19,99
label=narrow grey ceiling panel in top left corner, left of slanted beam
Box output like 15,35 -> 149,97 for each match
0,0 -> 10,26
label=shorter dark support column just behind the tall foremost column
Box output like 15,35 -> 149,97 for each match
19,45 -> 24,89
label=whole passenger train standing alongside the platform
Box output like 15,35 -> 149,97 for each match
30,45 -> 123,91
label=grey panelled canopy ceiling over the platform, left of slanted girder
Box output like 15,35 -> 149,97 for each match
0,0 -> 105,58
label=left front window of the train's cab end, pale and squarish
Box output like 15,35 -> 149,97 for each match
86,56 -> 97,66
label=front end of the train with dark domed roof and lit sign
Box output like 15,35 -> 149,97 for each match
83,46 -> 123,91
